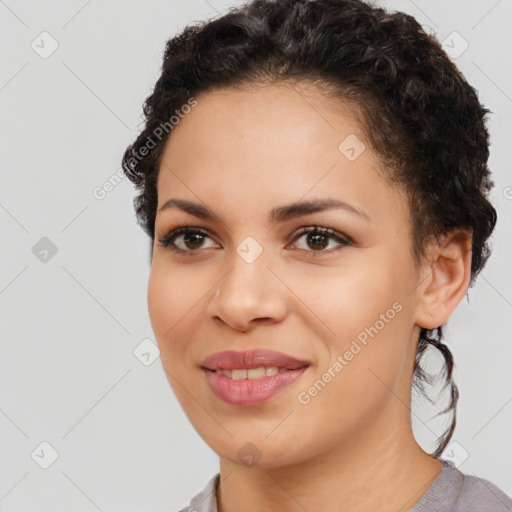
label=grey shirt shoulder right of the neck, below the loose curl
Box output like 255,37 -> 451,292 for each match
411,461 -> 512,512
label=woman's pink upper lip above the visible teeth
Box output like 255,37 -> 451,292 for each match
201,349 -> 309,370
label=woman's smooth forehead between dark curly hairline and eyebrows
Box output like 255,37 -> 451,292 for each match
158,84 -> 404,226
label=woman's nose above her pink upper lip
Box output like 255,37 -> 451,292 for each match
207,253 -> 289,332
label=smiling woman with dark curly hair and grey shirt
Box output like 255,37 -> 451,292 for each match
123,0 -> 512,512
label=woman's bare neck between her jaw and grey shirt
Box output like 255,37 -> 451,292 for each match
217,406 -> 443,512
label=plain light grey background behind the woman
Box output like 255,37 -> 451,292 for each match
0,0 -> 512,512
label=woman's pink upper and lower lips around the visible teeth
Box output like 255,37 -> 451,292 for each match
201,349 -> 309,406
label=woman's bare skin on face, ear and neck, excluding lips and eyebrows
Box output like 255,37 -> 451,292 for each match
148,84 -> 471,512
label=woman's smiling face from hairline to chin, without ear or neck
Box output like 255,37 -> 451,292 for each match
148,85 -> 428,467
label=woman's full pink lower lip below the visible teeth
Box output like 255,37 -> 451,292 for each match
203,366 -> 308,406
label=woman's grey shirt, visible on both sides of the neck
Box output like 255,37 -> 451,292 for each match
180,461 -> 512,512
